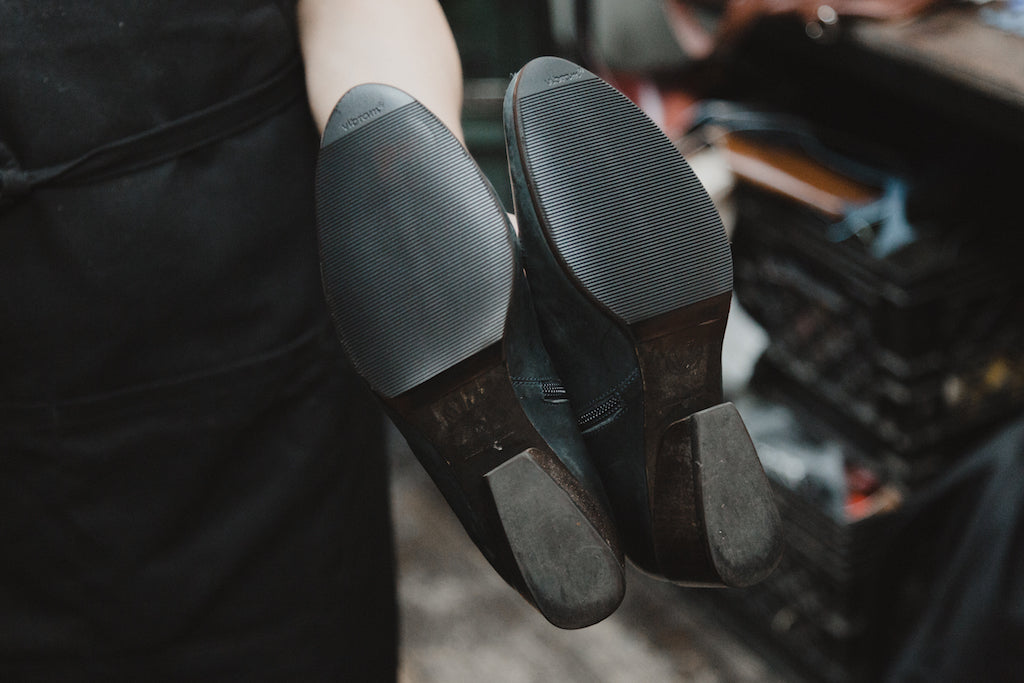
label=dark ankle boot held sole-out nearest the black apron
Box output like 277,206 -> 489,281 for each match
316,85 -> 625,629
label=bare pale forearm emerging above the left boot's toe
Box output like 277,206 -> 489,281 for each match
298,0 -> 462,138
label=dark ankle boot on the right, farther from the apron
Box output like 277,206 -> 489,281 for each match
504,57 -> 781,586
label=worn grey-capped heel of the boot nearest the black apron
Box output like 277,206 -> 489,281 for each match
484,449 -> 626,629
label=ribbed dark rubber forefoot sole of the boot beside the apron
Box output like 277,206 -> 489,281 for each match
316,86 -> 513,397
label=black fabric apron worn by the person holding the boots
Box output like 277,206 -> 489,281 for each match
0,0 -> 395,681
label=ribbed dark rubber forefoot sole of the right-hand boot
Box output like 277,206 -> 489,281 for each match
516,59 -> 732,324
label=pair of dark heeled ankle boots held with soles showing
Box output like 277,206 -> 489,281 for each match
316,57 -> 781,629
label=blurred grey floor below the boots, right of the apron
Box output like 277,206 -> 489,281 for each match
391,432 -> 792,683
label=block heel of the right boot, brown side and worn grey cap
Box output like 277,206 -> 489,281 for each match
651,403 -> 782,587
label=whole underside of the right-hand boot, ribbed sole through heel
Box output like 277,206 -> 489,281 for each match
510,57 -> 781,586
